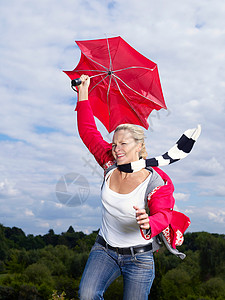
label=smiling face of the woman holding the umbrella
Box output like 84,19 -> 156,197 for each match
112,130 -> 141,165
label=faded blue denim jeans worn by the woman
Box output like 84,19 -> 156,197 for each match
79,242 -> 155,300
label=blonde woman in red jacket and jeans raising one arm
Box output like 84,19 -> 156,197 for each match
77,75 -> 174,300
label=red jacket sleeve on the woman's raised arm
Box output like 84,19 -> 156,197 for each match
76,100 -> 114,167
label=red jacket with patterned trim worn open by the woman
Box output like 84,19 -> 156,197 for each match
76,100 -> 190,248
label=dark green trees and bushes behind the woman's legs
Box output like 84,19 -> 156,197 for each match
0,224 -> 225,300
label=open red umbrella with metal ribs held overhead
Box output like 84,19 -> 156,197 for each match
64,37 -> 166,132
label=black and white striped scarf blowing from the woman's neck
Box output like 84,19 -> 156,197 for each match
117,125 -> 201,173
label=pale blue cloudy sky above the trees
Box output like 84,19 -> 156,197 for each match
0,0 -> 225,235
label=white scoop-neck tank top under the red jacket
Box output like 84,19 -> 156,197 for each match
99,169 -> 151,247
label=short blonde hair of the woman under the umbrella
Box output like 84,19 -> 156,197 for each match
114,124 -> 148,159
